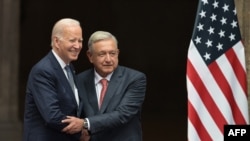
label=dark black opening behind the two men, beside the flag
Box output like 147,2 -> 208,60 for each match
19,0 -> 198,141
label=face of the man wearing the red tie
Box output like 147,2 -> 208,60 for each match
87,38 -> 119,77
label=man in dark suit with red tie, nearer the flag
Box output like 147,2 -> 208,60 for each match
62,31 -> 146,141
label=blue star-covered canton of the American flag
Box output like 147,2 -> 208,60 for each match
192,0 -> 241,65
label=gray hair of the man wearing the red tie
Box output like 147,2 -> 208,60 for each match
88,31 -> 118,51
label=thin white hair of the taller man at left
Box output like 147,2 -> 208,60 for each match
51,18 -> 81,46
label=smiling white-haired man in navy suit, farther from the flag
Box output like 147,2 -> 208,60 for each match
23,18 -> 86,141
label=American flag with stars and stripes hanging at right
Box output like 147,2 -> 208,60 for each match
186,0 -> 249,141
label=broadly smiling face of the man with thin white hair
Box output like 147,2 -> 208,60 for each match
53,25 -> 83,64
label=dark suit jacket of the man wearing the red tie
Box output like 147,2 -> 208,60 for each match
77,66 -> 146,141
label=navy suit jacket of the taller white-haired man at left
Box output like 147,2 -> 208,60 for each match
23,51 -> 80,141
